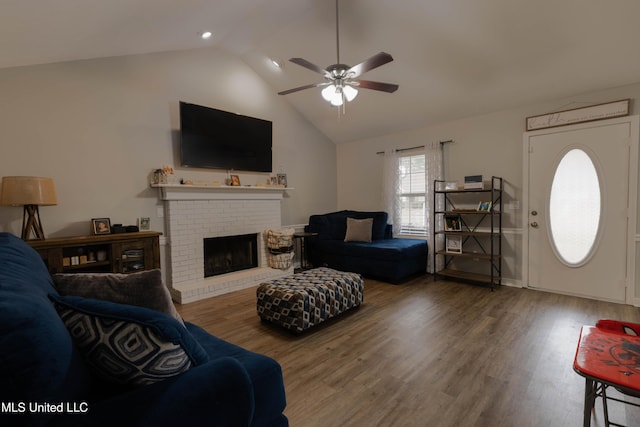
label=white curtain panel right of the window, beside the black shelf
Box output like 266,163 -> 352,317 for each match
424,142 -> 444,273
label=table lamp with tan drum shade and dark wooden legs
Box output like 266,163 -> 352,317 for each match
0,176 -> 58,240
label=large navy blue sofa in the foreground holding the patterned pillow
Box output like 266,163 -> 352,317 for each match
0,233 -> 288,427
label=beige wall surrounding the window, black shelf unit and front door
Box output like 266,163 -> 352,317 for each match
337,83 -> 640,289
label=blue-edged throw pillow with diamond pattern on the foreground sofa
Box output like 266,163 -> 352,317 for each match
50,295 -> 208,386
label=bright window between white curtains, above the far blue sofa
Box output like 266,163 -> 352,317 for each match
397,154 -> 428,236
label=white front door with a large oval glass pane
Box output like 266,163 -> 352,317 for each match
523,117 -> 638,302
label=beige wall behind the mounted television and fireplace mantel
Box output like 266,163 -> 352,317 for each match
0,49 -> 336,242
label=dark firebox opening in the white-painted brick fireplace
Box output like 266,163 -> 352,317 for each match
204,234 -> 258,277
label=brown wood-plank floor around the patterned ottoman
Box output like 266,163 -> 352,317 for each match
177,276 -> 640,427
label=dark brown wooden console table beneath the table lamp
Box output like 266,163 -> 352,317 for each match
27,231 -> 162,274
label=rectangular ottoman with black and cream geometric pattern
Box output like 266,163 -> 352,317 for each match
256,267 -> 364,332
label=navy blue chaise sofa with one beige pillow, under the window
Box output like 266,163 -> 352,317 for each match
305,210 -> 428,283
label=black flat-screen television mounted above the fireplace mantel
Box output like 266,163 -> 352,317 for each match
180,101 -> 273,172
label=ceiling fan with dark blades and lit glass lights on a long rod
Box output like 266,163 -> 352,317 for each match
278,0 -> 399,108
